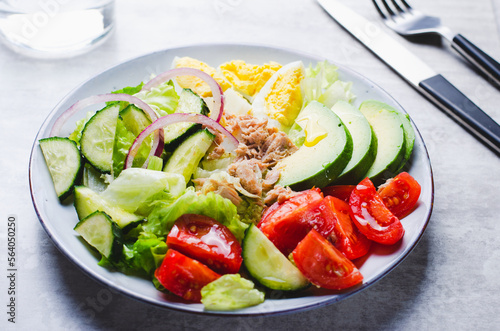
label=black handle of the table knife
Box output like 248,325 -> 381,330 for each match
419,75 -> 500,156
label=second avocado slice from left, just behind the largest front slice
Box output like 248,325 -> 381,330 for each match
332,100 -> 377,184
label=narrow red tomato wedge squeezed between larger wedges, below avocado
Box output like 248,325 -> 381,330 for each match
322,196 -> 372,260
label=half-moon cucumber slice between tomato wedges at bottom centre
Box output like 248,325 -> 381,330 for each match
242,224 -> 309,291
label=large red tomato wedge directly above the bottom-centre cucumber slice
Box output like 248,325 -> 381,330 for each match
257,189 -> 334,256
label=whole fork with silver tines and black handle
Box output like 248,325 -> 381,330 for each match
372,0 -> 500,87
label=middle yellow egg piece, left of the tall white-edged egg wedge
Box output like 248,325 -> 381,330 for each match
219,60 -> 281,97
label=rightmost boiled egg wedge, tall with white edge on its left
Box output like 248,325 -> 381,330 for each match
252,61 -> 305,129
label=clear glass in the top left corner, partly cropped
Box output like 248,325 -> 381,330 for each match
0,0 -> 115,58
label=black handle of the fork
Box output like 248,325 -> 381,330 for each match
451,34 -> 500,86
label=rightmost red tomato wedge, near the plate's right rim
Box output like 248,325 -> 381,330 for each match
378,172 -> 420,218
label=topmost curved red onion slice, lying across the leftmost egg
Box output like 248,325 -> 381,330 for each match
142,68 -> 224,122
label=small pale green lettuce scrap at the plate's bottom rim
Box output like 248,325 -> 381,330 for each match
201,274 -> 264,310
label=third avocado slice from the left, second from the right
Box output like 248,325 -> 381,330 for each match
359,100 -> 405,182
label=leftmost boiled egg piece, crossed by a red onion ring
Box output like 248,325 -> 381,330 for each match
175,57 -> 230,98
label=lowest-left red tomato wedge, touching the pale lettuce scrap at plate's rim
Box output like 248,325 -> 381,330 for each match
155,249 -> 220,302
